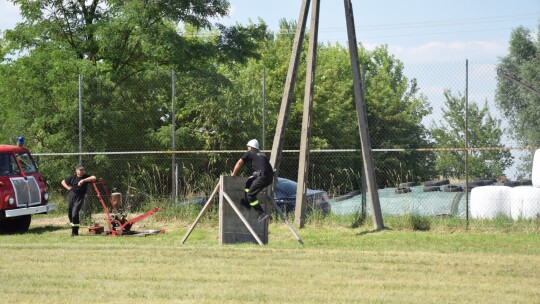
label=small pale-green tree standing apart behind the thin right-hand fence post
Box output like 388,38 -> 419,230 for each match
431,90 -> 513,179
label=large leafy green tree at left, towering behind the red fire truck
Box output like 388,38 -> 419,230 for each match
0,0 -> 266,188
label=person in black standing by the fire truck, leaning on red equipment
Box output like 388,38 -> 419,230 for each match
62,165 -> 96,236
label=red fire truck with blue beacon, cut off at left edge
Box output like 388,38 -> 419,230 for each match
0,142 -> 55,232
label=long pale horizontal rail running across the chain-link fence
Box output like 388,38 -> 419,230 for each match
33,146 -> 540,156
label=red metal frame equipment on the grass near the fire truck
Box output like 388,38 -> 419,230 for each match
92,179 -> 165,236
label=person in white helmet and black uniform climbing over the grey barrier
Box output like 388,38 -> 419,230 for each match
232,139 -> 274,222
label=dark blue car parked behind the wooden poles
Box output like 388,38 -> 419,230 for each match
274,177 -> 330,215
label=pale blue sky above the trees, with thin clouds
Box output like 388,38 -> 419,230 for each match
0,0 -> 540,64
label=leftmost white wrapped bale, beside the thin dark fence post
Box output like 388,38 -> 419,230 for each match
470,186 -> 512,219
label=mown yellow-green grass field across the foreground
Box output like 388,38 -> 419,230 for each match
0,218 -> 540,303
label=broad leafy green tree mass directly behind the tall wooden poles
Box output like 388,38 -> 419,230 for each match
212,20 -> 433,187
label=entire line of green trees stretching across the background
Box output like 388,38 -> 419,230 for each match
0,0 -> 540,194
